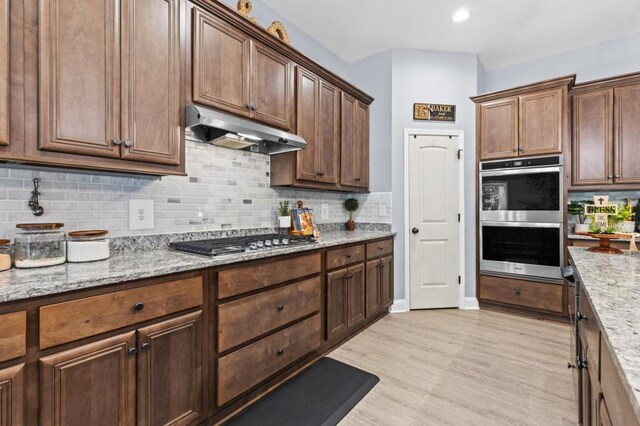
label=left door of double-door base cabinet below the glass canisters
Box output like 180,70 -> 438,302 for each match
40,331 -> 136,426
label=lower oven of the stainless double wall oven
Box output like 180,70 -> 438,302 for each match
480,221 -> 564,279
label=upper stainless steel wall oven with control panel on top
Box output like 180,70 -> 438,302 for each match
479,155 -> 564,223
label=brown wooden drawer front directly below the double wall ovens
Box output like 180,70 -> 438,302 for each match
480,275 -> 563,314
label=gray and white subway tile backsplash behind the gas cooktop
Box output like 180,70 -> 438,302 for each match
0,134 -> 391,237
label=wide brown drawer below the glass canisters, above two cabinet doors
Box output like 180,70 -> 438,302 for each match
40,276 -> 203,349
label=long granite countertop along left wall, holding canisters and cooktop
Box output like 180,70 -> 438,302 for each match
0,231 -> 395,303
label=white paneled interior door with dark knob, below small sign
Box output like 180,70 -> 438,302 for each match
407,135 -> 462,309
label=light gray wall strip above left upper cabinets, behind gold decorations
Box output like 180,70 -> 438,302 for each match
221,0 -> 349,78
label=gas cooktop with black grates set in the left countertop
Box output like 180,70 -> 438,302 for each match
169,234 -> 316,256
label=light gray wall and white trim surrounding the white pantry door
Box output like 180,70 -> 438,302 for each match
391,49 -> 478,299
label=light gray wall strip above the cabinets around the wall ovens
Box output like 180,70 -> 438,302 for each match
481,33 -> 640,93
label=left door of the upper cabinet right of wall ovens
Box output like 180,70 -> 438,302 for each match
572,89 -> 613,185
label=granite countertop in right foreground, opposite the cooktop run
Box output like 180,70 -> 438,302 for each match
569,247 -> 640,418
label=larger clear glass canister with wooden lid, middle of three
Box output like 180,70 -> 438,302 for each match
14,223 -> 67,268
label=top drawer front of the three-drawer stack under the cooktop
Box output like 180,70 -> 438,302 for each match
218,252 -> 321,299
